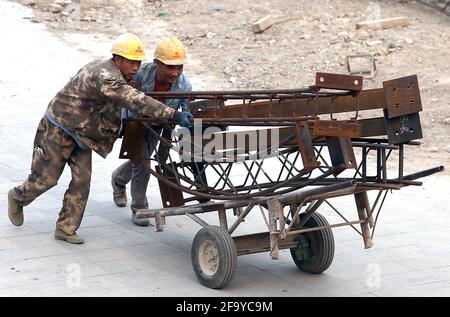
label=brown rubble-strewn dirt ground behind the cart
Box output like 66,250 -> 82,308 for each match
12,0 -> 450,174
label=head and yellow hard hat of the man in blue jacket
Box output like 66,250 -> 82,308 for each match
154,36 -> 187,84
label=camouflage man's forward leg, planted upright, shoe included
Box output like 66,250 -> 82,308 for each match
55,147 -> 92,243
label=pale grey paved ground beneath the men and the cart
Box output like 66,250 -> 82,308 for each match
0,1 -> 450,296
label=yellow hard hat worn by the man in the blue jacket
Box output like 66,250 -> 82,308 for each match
154,36 -> 187,65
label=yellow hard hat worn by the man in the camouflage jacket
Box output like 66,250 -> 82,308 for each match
111,33 -> 147,61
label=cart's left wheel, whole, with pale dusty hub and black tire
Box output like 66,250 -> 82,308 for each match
191,226 -> 237,288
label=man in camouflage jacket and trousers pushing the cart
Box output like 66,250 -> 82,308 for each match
8,33 -> 192,244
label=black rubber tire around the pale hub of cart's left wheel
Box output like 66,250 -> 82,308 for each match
191,226 -> 237,289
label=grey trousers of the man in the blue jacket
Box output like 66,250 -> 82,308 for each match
112,128 -> 172,210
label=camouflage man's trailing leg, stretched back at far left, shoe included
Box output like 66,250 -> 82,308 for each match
8,117 -> 67,226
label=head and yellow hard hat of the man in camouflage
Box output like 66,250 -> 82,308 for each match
111,33 -> 147,81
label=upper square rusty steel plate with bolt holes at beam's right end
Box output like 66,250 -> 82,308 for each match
383,75 -> 422,118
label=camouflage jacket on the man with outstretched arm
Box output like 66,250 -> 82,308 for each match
47,59 -> 173,158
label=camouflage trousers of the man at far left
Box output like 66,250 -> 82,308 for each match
13,116 -> 92,234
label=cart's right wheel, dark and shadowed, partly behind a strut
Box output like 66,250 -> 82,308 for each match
291,213 -> 334,274
